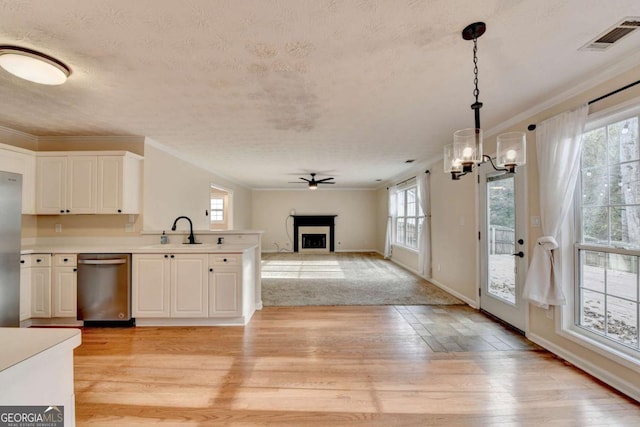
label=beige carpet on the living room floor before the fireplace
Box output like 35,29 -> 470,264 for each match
262,252 -> 464,307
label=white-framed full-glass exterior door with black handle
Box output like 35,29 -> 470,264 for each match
480,164 -> 527,331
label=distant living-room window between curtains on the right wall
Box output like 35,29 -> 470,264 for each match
394,185 -> 424,249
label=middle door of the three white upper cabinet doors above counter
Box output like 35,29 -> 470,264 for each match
65,156 -> 98,214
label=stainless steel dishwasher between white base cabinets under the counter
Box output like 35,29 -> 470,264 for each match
78,254 -> 135,326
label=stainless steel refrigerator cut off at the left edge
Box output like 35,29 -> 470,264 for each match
0,171 -> 22,327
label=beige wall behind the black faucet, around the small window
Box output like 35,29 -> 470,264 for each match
143,139 -> 251,231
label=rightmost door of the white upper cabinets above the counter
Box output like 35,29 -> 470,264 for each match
98,156 -> 124,214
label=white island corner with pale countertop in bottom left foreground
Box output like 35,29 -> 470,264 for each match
0,328 -> 81,426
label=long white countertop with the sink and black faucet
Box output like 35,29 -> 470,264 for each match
21,243 -> 257,254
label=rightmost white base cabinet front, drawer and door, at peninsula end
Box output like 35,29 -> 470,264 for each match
209,254 -> 242,317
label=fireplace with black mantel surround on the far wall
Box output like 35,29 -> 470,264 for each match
293,215 -> 336,253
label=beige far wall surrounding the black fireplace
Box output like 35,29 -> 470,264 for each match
251,188 -> 378,252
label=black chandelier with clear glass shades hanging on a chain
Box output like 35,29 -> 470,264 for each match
444,22 -> 527,180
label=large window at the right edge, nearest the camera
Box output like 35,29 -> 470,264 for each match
574,109 -> 640,357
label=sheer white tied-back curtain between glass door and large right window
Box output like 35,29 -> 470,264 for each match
523,104 -> 589,308
